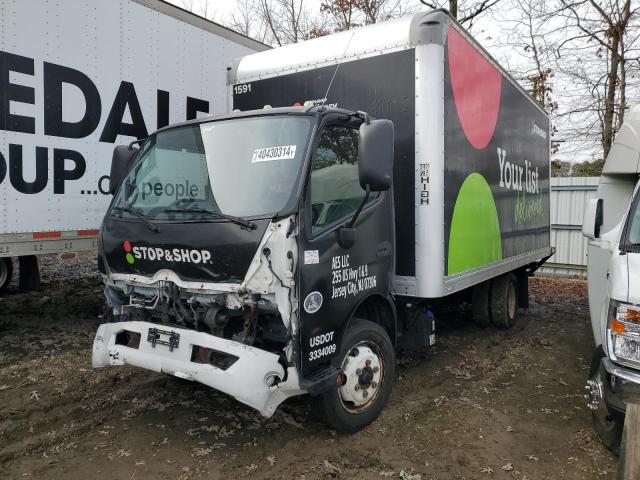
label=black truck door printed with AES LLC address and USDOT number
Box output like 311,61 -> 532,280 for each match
299,123 -> 395,375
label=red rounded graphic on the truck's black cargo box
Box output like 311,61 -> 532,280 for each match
447,27 -> 502,150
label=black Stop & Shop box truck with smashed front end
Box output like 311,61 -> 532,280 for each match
93,11 -> 551,432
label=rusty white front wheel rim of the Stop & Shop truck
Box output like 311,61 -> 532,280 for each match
339,342 -> 384,413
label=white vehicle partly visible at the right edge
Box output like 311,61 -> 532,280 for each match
582,106 -> 640,453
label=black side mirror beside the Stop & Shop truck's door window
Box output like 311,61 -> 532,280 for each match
358,120 -> 394,192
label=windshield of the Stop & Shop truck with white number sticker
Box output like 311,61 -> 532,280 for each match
112,115 -> 313,221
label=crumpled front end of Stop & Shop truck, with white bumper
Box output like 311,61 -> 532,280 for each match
92,217 -> 305,417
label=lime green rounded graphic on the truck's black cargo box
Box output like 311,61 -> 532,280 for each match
447,173 -> 502,275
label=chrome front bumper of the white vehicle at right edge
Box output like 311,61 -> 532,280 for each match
600,357 -> 640,412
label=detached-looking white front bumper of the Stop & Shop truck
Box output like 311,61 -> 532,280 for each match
91,322 -> 305,417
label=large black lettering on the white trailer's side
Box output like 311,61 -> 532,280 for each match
0,51 -> 216,199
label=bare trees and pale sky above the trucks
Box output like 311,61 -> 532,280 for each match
181,0 -> 640,176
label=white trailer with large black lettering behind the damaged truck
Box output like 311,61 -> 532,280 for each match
0,0 -> 267,291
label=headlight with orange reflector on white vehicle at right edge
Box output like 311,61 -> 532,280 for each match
607,300 -> 640,368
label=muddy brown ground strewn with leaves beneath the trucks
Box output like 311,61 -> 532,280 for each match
0,258 -> 616,480
